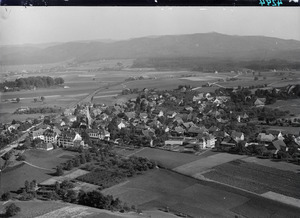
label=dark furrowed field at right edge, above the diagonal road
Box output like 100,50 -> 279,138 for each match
203,160 -> 300,199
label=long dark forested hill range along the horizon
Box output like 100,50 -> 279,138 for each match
0,33 -> 300,65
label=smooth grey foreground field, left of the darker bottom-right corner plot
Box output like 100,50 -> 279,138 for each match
103,170 -> 248,217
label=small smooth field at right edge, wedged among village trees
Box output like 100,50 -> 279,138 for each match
266,99 -> 300,116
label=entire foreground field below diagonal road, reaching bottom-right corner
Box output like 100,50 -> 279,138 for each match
102,169 -> 299,218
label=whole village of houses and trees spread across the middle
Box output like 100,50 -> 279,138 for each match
1,83 -> 300,162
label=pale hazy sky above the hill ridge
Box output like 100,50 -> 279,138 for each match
0,7 -> 300,45
